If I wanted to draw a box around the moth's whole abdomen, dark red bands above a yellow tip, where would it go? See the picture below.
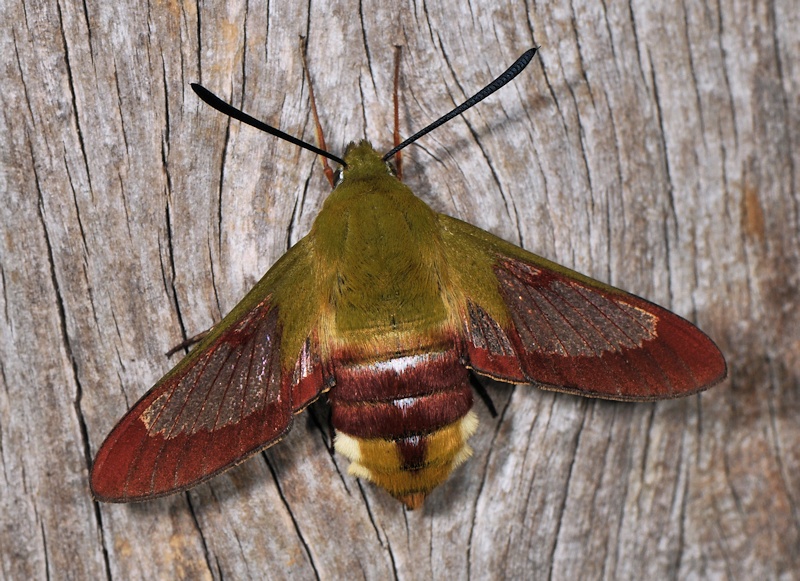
[328,344,478,508]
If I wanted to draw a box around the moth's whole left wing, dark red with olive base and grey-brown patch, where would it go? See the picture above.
[91,241,331,502]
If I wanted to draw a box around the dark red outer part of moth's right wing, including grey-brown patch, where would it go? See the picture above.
[473,257,727,401]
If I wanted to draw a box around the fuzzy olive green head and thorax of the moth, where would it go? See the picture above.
[309,141,448,342]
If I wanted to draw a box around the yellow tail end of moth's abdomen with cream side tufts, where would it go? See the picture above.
[334,411,478,509]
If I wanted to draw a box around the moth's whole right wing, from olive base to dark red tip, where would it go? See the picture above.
[440,216,727,401]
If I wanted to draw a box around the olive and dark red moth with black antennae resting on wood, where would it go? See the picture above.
[91,48,726,509]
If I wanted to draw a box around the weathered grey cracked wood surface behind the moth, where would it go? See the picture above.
[0,0,800,579]
